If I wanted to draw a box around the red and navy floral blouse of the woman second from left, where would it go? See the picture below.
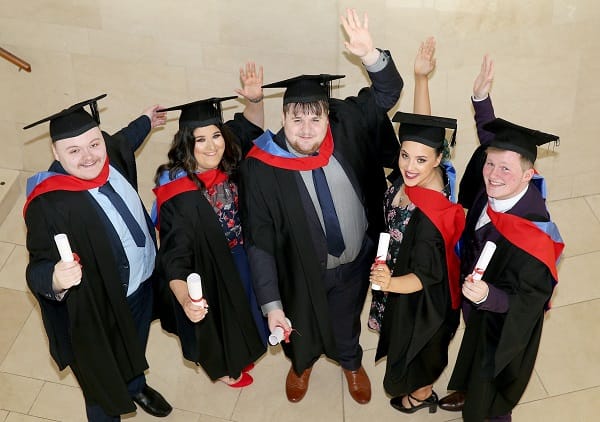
[203,180,244,249]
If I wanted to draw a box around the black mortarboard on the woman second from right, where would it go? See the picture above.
[392,111,456,149]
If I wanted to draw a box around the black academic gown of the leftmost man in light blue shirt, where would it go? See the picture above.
[25,117,154,416]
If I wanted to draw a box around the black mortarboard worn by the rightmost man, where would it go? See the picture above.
[483,119,560,163]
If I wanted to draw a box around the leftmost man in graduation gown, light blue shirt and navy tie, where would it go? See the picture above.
[23,95,172,421]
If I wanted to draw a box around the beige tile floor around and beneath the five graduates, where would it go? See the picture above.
[0,0,600,422]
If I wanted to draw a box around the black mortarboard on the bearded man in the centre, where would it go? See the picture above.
[263,73,346,105]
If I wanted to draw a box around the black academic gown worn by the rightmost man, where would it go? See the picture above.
[448,183,554,421]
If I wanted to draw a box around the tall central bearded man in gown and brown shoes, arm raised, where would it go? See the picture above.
[241,11,403,404]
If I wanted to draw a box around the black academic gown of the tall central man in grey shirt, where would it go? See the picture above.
[241,55,402,374]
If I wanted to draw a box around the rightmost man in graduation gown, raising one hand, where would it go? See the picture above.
[448,56,564,422]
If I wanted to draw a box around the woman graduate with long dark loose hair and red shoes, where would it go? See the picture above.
[154,63,267,387]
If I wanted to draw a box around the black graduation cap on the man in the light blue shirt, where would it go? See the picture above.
[23,94,106,142]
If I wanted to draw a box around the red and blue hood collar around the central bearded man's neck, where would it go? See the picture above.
[246,125,334,170]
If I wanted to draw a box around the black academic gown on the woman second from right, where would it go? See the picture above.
[375,181,459,396]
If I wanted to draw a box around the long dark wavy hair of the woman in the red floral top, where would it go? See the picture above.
[154,124,242,189]
